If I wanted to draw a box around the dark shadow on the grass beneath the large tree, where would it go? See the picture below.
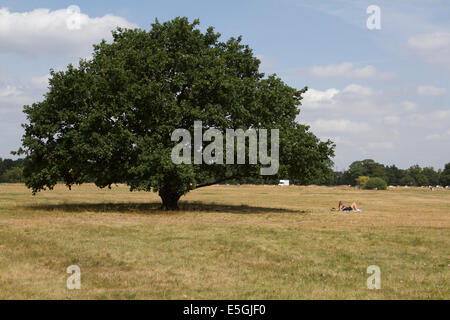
[26,201,308,214]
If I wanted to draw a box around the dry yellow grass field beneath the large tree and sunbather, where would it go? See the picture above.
[0,184,450,299]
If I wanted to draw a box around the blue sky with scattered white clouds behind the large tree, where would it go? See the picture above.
[0,0,450,170]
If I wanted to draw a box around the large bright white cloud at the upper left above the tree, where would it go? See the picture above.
[0,8,136,56]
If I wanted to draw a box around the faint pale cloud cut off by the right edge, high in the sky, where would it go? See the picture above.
[408,32,450,68]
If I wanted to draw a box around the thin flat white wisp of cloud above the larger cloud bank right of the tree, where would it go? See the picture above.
[309,62,394,79]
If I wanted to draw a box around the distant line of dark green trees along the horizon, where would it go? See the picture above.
[0,158,450,186]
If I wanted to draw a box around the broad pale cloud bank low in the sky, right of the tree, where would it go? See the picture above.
[299,83,450,170]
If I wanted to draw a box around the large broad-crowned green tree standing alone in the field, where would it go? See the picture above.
[19,18,334,207]
